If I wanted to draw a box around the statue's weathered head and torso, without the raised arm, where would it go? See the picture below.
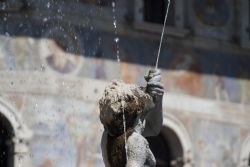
[99,81,155,167]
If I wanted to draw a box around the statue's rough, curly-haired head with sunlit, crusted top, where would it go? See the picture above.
[99,81,153,136]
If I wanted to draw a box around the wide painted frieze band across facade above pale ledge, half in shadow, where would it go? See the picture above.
[0,30,250,104]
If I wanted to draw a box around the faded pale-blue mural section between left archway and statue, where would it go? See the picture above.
[23,97,103,167]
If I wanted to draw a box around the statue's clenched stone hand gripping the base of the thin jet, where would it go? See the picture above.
[145,69,164,102]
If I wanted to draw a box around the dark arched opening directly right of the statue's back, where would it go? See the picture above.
[147,127,184,167]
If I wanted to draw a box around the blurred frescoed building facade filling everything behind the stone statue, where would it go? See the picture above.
[0,0,250,167]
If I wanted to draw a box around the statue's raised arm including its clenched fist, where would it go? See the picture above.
[143,70,164,136]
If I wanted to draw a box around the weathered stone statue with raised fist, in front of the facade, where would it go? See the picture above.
[99,70,164,167]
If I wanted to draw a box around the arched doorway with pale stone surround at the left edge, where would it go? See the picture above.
[0,98,32,167]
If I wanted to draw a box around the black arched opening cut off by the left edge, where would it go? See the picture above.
[0,114,14,167]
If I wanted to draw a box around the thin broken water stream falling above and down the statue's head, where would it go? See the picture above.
[112,1,128,162]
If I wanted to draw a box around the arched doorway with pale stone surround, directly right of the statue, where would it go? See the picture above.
[147,114,193,167]
